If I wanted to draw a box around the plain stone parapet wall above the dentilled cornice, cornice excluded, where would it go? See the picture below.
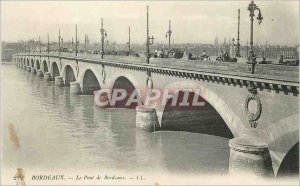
[13,52,299,82]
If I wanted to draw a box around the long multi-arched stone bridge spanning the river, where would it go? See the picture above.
[13,53,299,176]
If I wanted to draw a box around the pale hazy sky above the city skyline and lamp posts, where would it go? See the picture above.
[1,0,299,45]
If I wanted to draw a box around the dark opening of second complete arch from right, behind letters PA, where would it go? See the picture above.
[111,76,142,109]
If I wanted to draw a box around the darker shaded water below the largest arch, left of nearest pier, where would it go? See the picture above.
[157,132,229,173]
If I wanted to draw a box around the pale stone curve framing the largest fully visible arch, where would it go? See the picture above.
[155,81,245,137]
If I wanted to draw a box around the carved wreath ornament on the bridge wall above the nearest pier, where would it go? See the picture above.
[244,84,262,128]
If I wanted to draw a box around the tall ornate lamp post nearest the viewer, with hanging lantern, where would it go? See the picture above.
[248,1,263,74]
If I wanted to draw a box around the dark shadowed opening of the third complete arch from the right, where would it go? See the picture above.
[82,69,101,95]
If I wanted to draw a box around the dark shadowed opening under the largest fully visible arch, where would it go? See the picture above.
[160,91,234,139]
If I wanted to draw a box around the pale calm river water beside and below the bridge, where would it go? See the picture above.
[1,65,237,184]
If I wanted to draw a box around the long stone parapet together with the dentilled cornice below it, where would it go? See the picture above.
[15,52,299,94]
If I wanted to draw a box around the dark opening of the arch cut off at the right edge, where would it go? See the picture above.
[277,142,299,178]
